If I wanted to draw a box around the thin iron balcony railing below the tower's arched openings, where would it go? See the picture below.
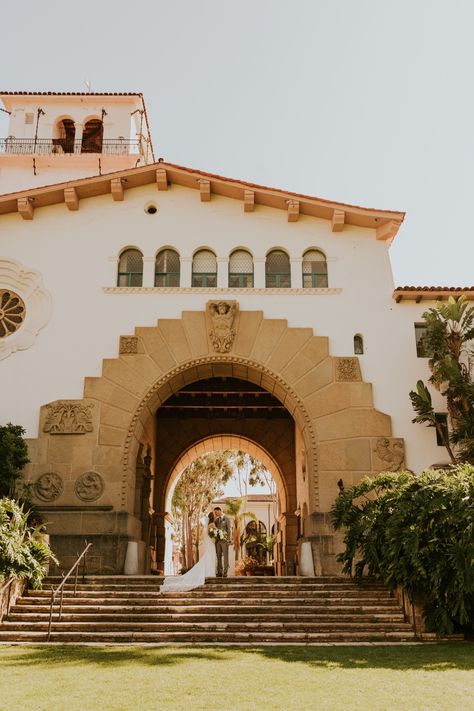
[0,136,144,156]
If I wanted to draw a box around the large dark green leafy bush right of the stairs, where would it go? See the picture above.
[331,464,474,634]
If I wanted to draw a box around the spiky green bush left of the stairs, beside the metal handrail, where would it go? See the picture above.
[0,498,57,588]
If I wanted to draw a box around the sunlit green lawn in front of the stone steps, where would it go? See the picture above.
[0,643,474,711]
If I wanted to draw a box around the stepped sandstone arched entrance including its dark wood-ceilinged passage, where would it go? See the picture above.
[28,301,403,573]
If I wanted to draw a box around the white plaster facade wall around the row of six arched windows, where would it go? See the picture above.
[0,186,445,470]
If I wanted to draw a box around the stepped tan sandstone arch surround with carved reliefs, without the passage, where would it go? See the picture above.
[28,302,404,573]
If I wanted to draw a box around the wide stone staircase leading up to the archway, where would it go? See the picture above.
[0,576,415,645]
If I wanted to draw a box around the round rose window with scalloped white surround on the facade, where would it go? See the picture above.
[0,259,51,360]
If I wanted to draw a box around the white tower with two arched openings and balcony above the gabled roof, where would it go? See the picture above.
[0,91,154,194]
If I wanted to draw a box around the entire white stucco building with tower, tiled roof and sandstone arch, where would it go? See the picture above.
[0,92,468,572]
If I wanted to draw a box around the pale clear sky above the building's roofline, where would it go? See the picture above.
[0,0,474,286]
